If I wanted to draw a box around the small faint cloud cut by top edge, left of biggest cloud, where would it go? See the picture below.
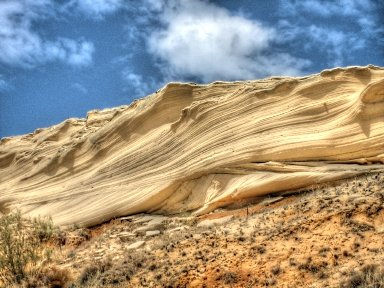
[68,0,123,19]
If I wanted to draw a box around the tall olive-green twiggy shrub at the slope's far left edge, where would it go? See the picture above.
[0,212,53,287]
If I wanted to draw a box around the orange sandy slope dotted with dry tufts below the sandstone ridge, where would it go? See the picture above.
[50,173,384,288]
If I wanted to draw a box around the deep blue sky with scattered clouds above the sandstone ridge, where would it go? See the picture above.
[0,0,384,137]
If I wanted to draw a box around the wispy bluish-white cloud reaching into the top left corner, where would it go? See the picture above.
[0,0,94,67]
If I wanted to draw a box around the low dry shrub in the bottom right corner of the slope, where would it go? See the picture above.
[340,265,384,288]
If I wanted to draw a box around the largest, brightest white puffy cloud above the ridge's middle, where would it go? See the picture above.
[144,0,309,82]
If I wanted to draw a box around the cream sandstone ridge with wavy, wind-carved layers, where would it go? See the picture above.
[0,65,384,226]
